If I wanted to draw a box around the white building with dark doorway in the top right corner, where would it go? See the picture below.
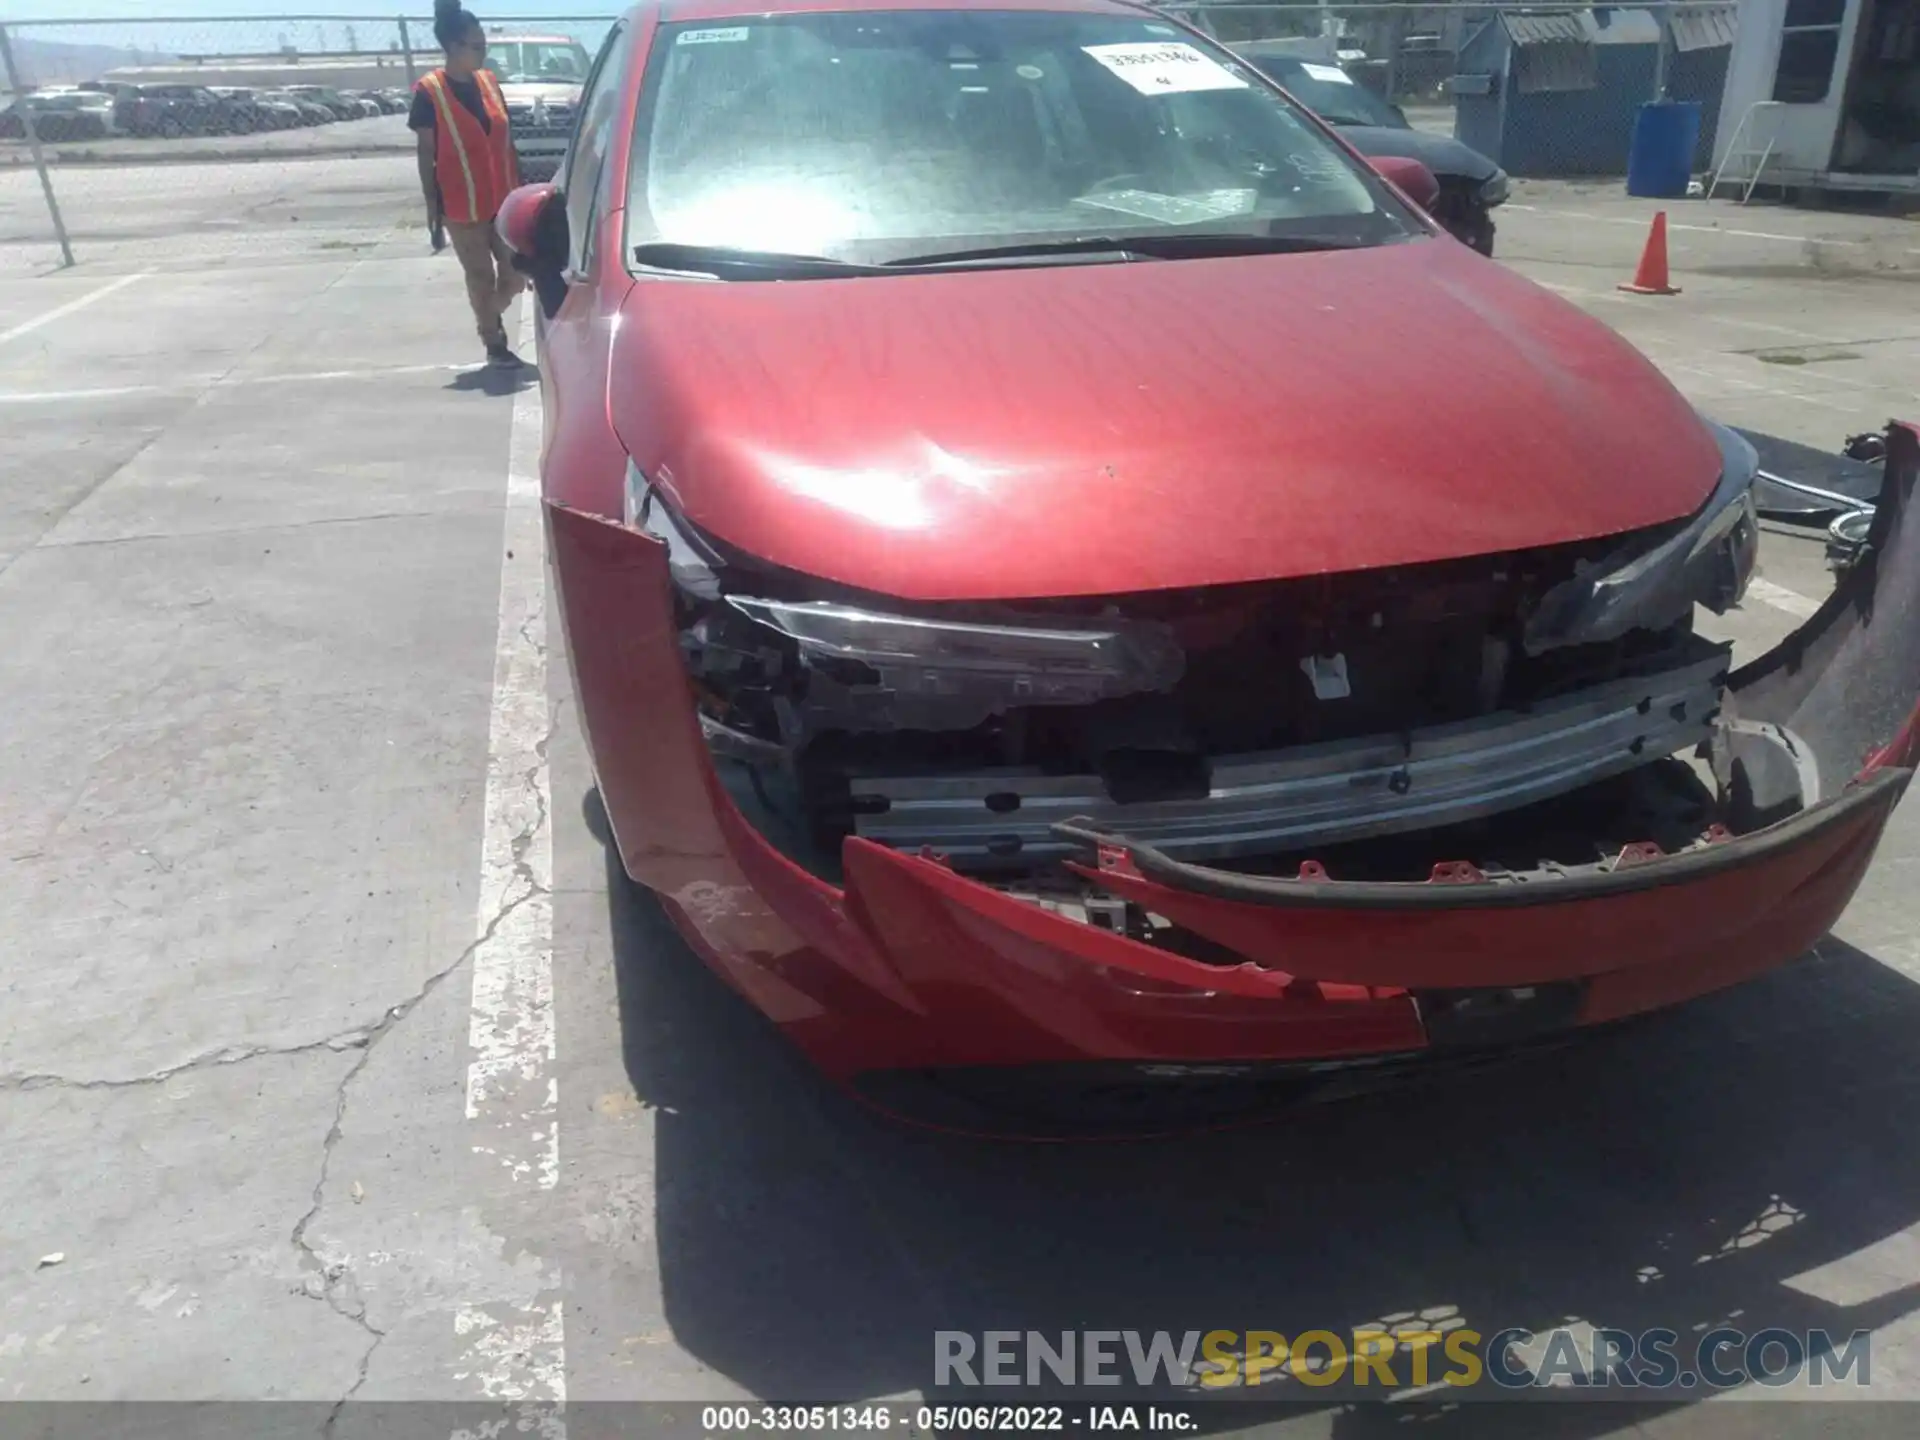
[1720,0,1920,192]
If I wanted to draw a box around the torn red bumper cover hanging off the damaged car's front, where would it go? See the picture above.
[547,426,1920,1079]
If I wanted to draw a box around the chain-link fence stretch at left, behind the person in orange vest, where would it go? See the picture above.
[0,10,616,273]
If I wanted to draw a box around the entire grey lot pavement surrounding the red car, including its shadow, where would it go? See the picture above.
[0,161,1920,1438]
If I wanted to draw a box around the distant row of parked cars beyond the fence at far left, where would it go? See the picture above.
[0,81,409,142]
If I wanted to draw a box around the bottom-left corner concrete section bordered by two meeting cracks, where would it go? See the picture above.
[0,1050,372,1400]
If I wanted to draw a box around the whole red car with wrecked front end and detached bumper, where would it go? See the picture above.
[501,0,1920,1123]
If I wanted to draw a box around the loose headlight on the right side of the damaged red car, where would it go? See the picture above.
[1523,420,1761,655]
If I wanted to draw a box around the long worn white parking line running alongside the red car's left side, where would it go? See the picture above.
[455,303,566,1432]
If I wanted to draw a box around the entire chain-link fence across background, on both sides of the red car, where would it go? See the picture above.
[0,0,1740,267]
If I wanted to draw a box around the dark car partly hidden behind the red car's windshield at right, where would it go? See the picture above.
[1235,40,1507,255]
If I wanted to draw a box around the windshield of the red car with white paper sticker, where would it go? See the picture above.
[628,10,1419,265]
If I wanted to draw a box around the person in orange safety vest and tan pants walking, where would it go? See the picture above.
[407,0,524,365]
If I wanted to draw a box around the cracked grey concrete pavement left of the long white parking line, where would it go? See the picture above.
[0,219,529,1405]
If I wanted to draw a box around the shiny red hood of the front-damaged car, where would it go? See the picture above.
[609,238,1720,601]
